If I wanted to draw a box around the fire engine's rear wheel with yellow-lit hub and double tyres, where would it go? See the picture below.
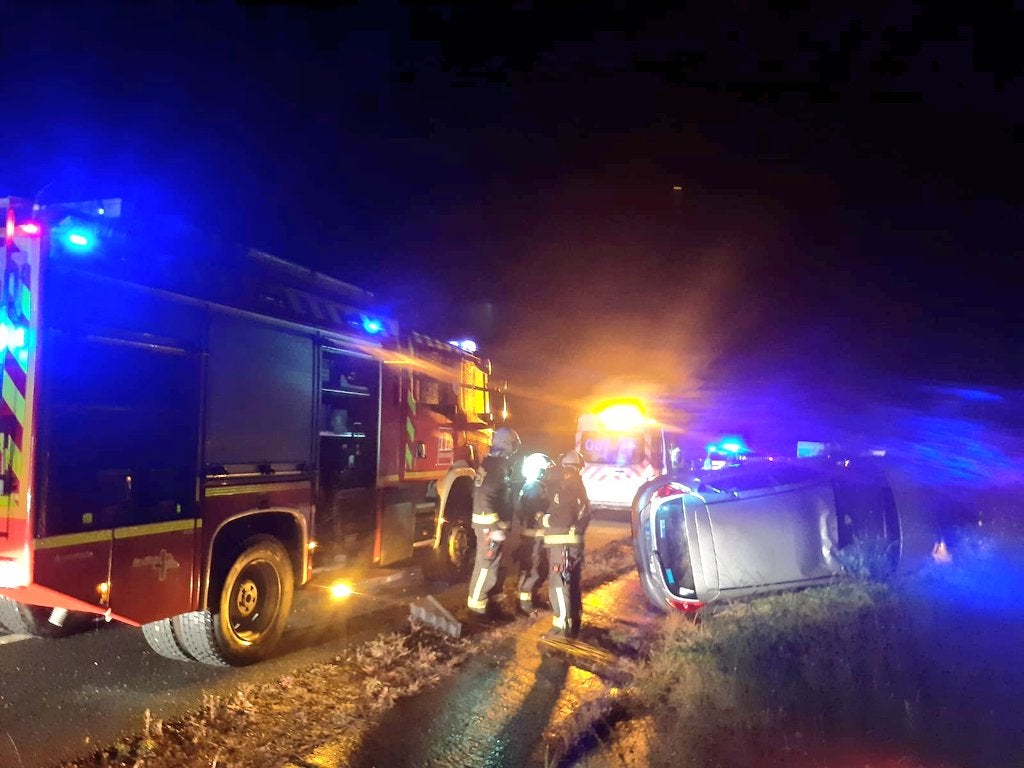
[171,537,295,667]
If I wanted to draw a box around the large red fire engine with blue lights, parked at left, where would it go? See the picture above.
[0,198,504,665]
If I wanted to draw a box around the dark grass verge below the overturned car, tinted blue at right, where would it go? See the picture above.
[574,537,1024,768]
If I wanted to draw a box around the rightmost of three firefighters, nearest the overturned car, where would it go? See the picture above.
[542,451,590,638]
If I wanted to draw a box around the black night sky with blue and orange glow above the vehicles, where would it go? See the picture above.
[0,2,1024,450]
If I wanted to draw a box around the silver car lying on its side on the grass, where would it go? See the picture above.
[632,458,901,611]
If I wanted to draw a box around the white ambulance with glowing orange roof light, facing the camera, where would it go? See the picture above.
[575,399,671,510]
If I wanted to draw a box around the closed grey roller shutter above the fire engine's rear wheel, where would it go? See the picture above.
[206,315,314,466]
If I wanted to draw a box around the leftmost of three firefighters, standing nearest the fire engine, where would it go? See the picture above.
[466,427,521,615]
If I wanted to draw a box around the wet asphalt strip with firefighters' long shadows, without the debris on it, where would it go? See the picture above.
[344,572,660,768]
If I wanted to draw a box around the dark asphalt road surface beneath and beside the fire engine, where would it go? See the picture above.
[0,520,629,768]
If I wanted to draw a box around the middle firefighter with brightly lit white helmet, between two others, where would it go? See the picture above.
[516,454,555,615]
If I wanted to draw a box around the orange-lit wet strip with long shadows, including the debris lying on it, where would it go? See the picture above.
[339,572,660,768]
